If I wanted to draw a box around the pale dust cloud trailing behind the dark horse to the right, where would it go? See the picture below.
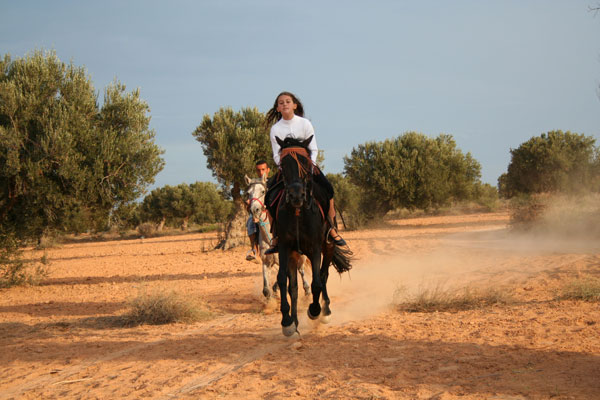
[328,220,600,324]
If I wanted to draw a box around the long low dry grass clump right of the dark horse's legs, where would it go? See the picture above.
[394,285,512,312]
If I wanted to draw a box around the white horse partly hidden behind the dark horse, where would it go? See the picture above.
[244,175,310,299]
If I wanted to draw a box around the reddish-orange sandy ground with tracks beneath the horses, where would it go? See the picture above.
[0,213,600,399]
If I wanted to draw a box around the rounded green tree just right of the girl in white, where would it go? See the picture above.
[344,132,481,217]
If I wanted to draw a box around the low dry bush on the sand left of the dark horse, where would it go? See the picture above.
[123,292,212,325]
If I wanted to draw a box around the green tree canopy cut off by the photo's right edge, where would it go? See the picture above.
[498,130,600,197]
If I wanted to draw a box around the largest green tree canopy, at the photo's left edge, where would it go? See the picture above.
[0,51,164,239]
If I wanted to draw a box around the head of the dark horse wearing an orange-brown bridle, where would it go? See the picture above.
[276,136,313,208]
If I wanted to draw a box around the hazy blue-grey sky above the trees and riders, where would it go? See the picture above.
[0,0,600,187]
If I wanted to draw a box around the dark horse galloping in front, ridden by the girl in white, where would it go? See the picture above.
[271,136,351,336]
